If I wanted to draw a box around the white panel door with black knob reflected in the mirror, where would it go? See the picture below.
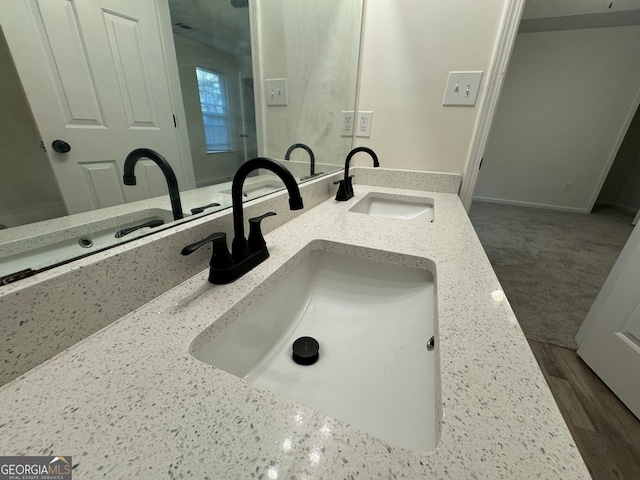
[0,0,195,213]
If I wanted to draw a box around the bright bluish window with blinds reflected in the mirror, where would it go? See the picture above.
[196,67,231,153]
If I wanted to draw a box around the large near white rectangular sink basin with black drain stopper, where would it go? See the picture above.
[191,244,439,451]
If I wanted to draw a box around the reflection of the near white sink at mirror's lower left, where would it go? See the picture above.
[0,208,173,277]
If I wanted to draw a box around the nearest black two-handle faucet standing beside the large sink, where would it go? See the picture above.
[181,157,303,285]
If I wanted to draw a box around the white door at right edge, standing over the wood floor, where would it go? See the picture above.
[576,222,640,418]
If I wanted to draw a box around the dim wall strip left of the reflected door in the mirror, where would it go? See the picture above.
[0,32,67,227]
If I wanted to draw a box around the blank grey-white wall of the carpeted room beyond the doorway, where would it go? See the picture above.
[475,26,640,211]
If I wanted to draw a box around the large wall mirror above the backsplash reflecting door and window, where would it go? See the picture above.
[0,0,363,284]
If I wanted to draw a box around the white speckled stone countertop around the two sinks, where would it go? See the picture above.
[0,185,590,479]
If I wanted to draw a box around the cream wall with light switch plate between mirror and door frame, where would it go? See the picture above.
[357,0,508,173]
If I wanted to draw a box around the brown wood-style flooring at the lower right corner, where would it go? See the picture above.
[529,340,640,480]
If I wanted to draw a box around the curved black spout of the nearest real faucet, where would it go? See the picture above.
[231,157,304,262]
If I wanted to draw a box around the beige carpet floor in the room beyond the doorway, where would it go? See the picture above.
[469,202,633,350]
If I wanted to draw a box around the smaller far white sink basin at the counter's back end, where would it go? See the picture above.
[349,192,433,222]
